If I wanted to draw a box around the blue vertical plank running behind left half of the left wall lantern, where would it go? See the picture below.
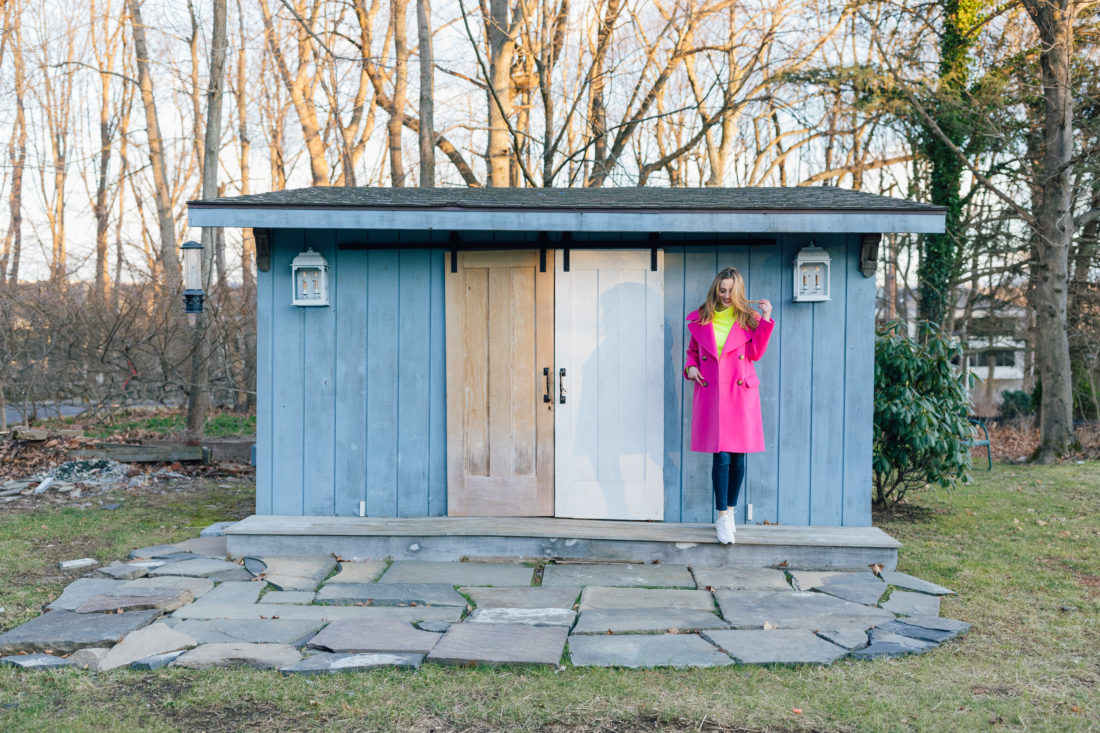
[271,229,306,516]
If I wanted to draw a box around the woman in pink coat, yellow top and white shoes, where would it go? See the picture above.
[684,267,776,545]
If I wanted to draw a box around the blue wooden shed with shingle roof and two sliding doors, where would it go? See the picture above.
[189,188,945,563]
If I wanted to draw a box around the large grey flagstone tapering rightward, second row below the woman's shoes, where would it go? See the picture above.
[714,591,893,631]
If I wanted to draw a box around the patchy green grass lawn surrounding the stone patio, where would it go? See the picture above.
[0,462,1100,731]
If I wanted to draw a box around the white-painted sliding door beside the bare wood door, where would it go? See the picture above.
[554,250,664,519]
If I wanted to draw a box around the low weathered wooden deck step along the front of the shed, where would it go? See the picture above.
[226,515,901,570]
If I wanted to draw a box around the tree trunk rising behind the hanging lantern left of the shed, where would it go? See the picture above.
[187,0,226,438]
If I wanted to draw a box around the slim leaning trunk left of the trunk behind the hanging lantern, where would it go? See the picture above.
[127,0,179,293]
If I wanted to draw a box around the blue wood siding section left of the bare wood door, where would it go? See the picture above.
[256,229,447,516]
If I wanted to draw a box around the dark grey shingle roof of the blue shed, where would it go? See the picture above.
[189,186,945,214]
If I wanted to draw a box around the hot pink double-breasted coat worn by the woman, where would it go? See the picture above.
[684,310,776,453]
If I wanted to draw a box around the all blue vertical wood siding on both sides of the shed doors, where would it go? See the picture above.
[256,230,875,519]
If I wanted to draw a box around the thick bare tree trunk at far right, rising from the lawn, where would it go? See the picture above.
[1024,0,1077,463]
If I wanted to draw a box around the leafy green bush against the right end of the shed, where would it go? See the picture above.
[872,320,971,510]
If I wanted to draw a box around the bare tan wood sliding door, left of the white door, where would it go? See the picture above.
[444,250,554,516]
